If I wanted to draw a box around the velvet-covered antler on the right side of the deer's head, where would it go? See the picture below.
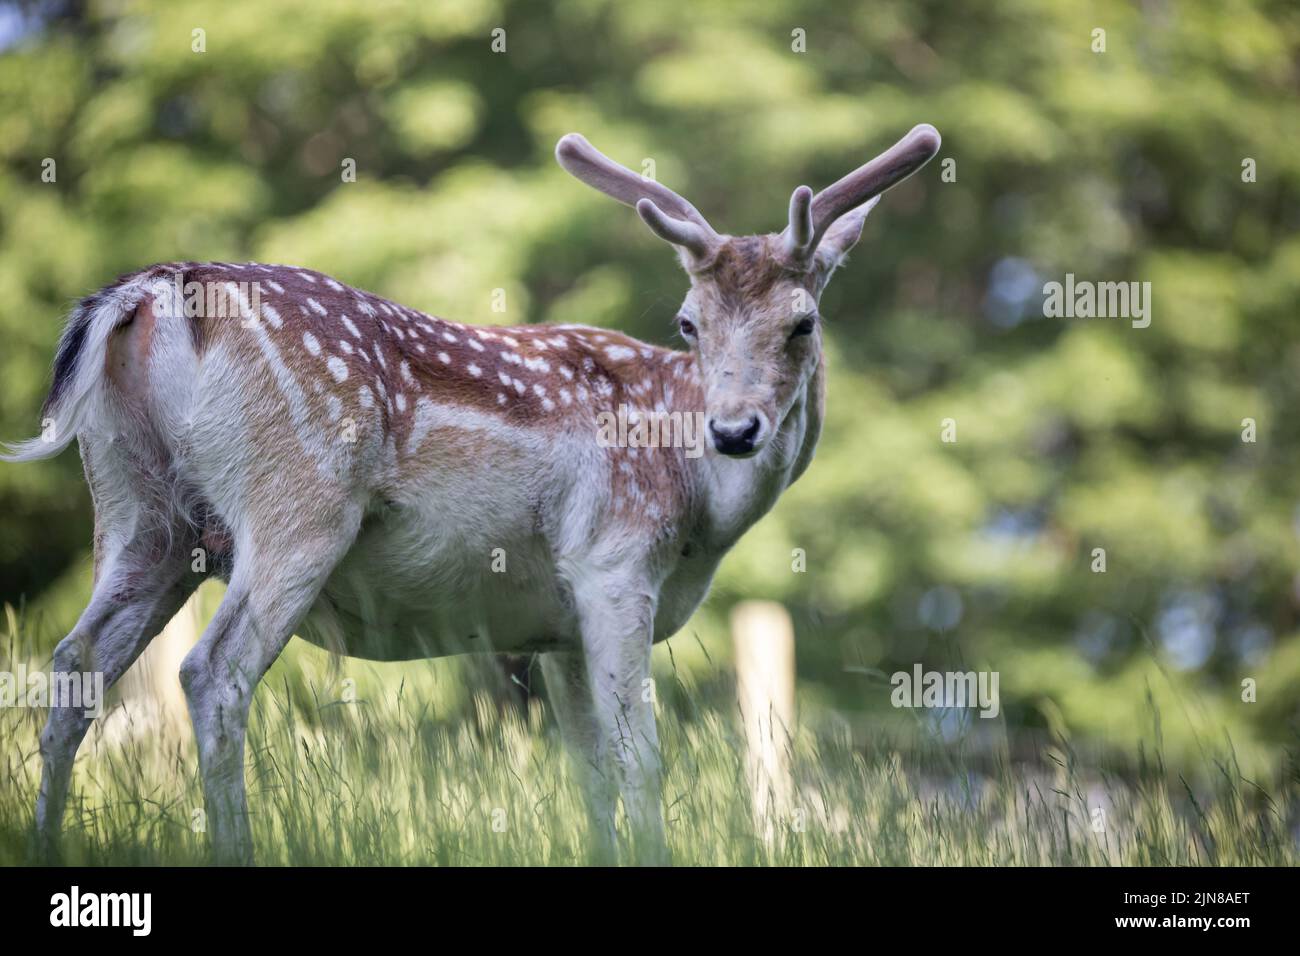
[781,124,941,261]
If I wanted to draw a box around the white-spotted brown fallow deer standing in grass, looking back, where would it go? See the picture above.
[4,124,940,865]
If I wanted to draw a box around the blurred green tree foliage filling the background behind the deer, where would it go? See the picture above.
[0,0,1300,779]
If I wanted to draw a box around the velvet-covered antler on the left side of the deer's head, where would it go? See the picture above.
[555,133,722,265]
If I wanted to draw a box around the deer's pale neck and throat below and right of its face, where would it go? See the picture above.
[694,360,826,553]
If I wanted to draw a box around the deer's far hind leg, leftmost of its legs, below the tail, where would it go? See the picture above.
[36,542,198,858]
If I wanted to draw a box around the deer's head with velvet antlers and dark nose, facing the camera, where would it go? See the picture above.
[555,124,940,458]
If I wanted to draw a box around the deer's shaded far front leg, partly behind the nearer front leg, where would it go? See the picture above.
[542,652,618,864]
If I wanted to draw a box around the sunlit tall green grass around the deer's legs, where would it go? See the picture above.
[0,613,1300,865]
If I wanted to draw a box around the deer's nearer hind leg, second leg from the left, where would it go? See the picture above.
[181,502,361,864]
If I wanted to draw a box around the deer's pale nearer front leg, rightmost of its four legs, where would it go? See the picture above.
[575,581,668,864]
